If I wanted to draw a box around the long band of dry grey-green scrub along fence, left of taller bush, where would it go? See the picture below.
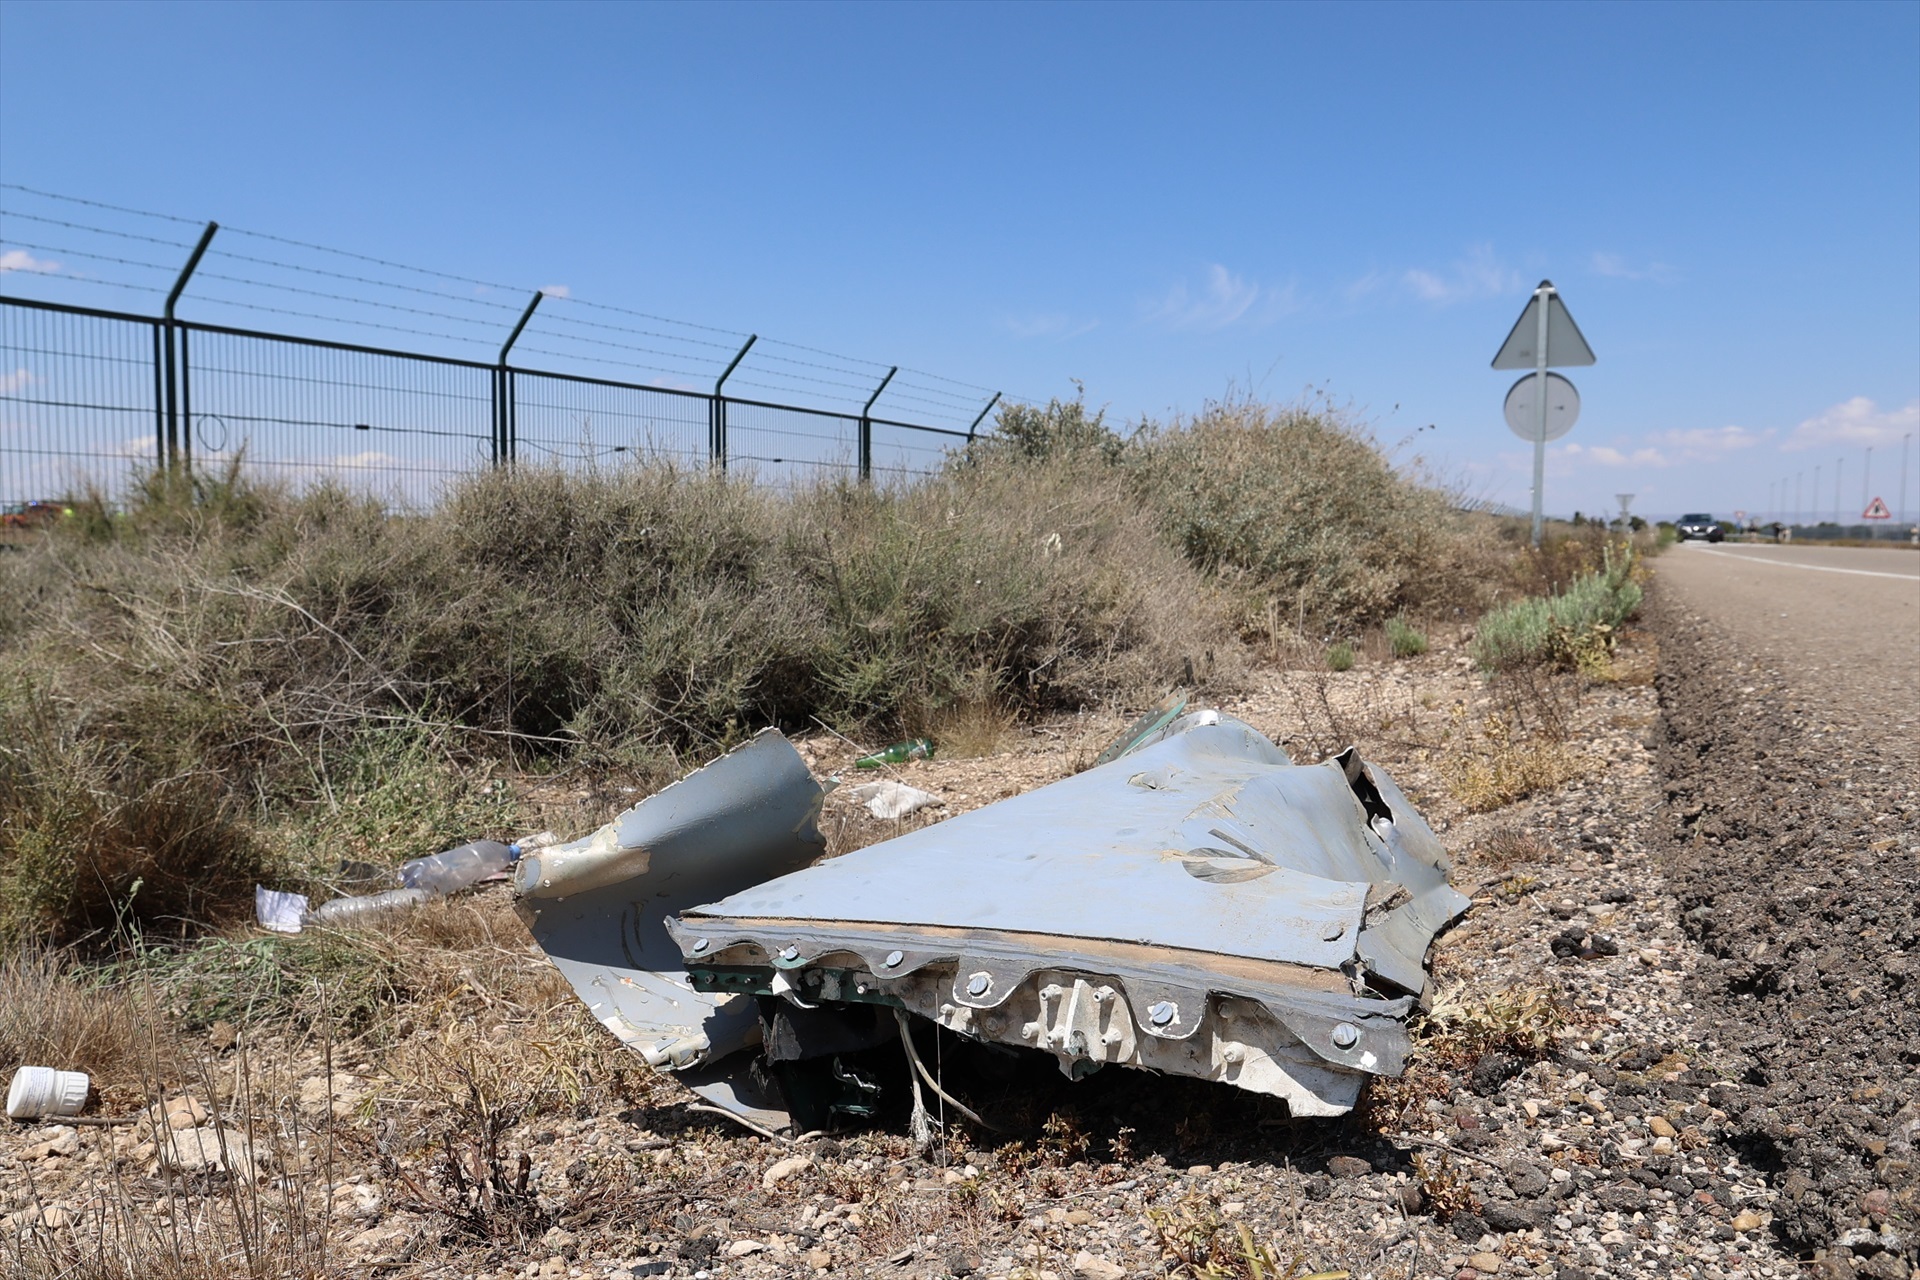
[0,453,1231,940]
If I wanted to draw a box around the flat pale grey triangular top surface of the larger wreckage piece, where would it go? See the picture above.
[689,720,1420,969]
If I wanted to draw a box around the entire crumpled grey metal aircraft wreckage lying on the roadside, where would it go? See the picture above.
[515,710,1467,1126]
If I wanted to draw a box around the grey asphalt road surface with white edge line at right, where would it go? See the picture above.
[1653,543,1920,762]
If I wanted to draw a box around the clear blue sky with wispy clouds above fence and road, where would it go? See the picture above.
[0,0,1920,514]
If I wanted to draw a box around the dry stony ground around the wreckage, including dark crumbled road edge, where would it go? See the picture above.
[0,557,1920,1280]
